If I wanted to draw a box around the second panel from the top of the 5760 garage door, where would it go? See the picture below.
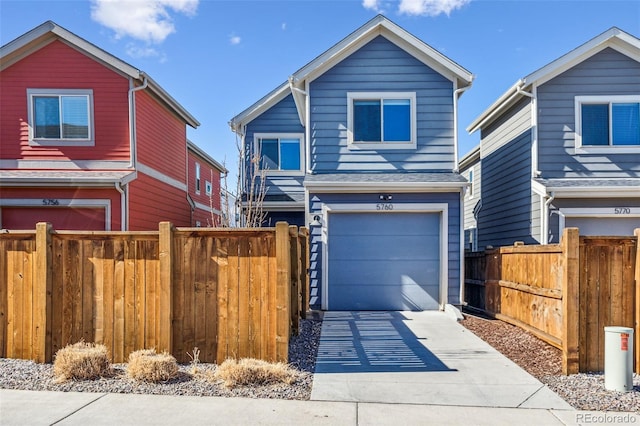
[329,235,440,260]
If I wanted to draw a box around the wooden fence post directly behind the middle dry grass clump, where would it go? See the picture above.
[157,222,173,352]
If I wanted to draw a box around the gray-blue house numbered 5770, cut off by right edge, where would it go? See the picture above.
[461,28,640,248]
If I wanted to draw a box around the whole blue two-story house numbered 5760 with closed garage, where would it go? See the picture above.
[230,15,472,310]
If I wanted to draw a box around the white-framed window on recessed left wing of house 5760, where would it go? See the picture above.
[253,133,304,175]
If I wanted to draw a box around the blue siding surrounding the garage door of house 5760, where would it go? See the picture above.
[309,192,461,308]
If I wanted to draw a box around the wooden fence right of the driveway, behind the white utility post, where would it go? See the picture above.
[465,228,640,374]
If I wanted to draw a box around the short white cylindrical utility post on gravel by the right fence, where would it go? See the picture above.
[604,327,633,392]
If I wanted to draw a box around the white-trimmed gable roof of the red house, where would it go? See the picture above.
[0,21,200,128]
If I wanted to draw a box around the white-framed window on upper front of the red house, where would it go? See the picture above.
[27,89,95,146]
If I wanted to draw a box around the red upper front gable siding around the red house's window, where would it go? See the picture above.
[0,41,131,161]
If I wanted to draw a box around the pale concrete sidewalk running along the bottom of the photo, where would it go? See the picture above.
[0,389,640,426]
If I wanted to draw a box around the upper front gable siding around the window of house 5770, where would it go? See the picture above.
[538,48,640,178]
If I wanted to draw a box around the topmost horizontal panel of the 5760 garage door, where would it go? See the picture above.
[329,213,439,237]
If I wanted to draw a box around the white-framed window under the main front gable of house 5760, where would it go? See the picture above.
[347,92,417,149]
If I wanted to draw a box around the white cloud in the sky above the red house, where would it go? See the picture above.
[91,0,199,43]
